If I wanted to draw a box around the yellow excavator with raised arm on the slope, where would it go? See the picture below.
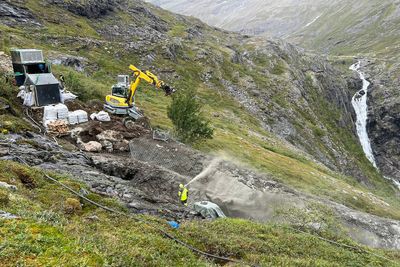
[104,65,175,123]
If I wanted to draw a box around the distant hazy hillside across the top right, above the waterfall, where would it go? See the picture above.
[145,0,399,55]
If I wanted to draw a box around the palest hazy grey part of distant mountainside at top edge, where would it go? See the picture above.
[148,0,332,38]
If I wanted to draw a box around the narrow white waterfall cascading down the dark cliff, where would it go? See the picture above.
[350,62,378,169]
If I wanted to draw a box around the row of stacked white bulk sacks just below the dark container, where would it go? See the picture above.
[43,104,88,127]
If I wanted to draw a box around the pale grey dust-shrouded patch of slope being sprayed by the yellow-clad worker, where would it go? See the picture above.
[187,158,302,221]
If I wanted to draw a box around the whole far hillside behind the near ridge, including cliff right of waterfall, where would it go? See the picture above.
[148,0,400,186]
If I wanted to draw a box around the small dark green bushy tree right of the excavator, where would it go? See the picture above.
[168,89,213,143]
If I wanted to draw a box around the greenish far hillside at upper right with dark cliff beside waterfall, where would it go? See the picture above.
[291,1,400,184]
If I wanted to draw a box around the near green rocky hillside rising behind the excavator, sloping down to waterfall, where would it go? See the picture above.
[1,0,398,220]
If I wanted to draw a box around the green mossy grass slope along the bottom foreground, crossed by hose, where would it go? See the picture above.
[0,161,400,266]
